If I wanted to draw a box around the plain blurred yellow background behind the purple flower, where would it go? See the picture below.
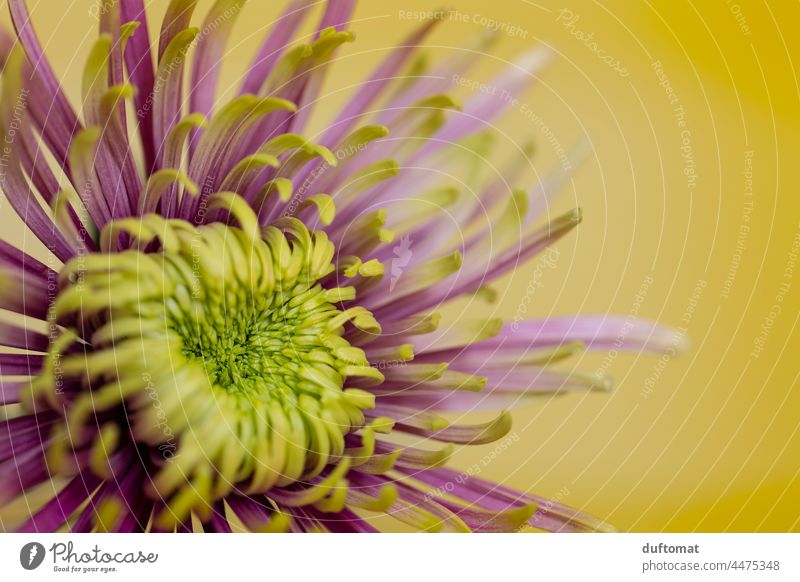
[0,0,800,531]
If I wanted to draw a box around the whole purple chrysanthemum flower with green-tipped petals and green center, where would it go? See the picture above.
[0,0,671,532]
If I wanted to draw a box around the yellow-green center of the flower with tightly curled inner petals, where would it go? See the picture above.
[29,194,383,526]
